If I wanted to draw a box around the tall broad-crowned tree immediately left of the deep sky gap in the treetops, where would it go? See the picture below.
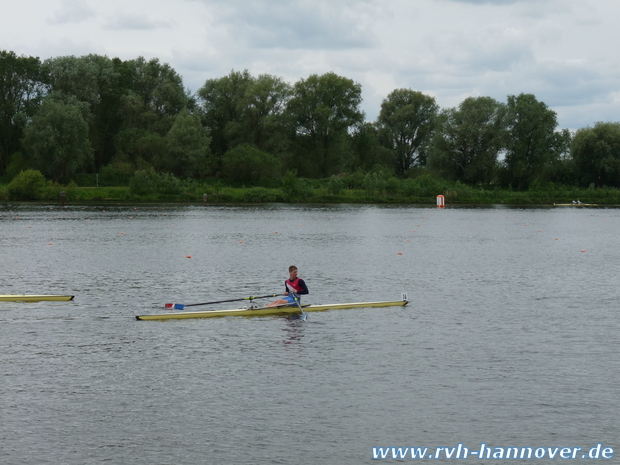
[288,73,364,177]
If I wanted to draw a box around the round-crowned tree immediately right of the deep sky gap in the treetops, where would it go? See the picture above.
[377,89,439,175]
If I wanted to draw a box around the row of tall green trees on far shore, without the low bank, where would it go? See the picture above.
[0,51,620,190]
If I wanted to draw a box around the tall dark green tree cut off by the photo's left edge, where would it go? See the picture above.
[0,50,45,175]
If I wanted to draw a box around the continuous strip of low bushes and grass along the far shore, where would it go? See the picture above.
[0,170,620,206]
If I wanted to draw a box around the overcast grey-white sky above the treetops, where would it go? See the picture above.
[0,0,620,130]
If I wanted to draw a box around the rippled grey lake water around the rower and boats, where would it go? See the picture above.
[0,204,620,465]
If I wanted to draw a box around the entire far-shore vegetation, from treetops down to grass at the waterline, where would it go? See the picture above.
[0,50,620,205]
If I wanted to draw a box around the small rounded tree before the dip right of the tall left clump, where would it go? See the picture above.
[164,110,211,177]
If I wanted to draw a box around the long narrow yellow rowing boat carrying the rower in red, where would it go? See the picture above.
[136,300,409,320]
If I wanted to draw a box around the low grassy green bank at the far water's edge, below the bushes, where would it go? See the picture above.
[0,178,620,205]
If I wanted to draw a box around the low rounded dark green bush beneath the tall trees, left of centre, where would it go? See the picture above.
[222,144,280,183]
